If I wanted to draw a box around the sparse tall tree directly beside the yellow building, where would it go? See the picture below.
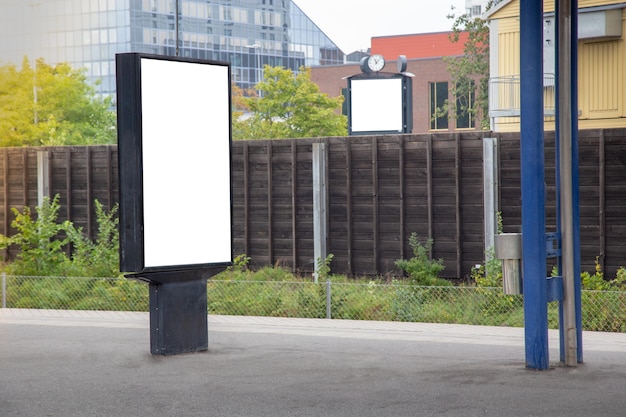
[442,1,494,129]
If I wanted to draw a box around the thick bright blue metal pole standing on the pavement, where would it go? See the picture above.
[520,0,550,370]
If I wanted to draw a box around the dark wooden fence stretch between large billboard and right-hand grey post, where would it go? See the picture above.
[233,134,483,277]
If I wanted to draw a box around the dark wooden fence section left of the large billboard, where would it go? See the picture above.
[0,146,118,244]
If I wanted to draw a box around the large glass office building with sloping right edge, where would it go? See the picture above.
[0,0,344,95]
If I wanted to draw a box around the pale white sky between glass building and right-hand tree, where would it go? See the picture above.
[294,0,465,54]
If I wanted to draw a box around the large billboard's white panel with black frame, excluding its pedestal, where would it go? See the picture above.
[116,53,232,273]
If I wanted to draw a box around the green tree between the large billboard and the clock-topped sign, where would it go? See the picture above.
[233,66,347,139]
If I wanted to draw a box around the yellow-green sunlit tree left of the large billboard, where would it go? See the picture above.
[0,58,116,146]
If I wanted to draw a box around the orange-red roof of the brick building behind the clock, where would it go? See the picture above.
[372,32,469,61]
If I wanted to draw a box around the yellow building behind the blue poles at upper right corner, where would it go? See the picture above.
[487,0,626,132]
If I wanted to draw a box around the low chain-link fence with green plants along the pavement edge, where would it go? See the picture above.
[1,274,626,332]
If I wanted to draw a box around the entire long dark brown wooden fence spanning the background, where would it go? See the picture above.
[0,129,626,279]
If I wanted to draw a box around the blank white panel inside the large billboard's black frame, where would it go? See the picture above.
[140,57,232,268]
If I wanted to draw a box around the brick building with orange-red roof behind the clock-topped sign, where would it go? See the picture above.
[311,32,480,133]
